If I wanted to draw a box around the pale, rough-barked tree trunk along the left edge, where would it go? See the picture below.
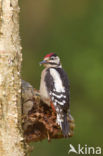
[0,0,25,156]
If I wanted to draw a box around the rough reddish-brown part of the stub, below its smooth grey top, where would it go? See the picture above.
[24,99,73,142]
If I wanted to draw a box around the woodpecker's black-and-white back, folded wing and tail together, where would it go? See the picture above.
[45,68,70,136]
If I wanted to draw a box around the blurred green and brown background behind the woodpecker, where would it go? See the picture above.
[20,0,103,156]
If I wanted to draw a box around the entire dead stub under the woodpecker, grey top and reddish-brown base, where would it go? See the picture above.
[22,81,74,142]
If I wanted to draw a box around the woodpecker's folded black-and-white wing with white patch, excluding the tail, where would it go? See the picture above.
[45,68,70,109]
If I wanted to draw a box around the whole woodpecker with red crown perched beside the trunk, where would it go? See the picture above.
[40,53,70,137]
